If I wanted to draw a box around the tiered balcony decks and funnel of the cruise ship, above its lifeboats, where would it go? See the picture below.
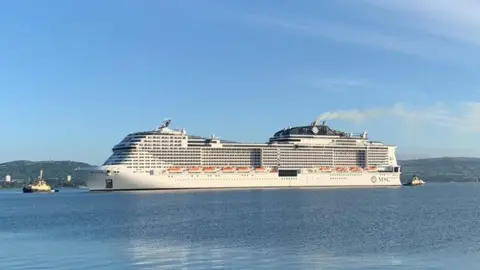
[105,118,395,169]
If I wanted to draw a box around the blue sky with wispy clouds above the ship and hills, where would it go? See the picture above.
[0,0,480,164]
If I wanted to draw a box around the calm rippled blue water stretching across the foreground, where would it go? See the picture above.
[0,183,480,270]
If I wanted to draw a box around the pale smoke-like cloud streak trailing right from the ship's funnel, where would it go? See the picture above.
[317,102,480,133]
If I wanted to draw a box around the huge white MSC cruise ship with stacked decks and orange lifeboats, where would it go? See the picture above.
[82,119,401,191]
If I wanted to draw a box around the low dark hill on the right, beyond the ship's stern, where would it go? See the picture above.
[398,157,480,182]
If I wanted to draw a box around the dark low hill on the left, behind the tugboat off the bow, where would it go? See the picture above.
[0,160,92,185]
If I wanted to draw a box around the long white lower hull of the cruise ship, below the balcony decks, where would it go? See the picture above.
[87,168,402,191]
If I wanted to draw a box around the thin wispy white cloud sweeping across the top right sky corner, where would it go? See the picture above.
[183,0,480,64]
